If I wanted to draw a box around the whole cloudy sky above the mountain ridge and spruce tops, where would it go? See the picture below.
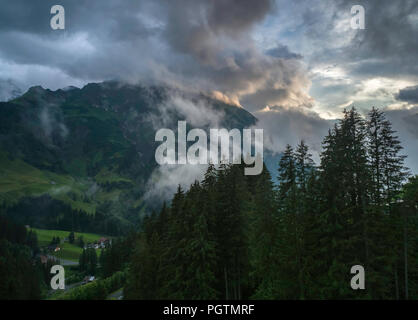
[0,0,418,173]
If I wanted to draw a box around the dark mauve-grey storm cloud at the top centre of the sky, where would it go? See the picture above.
[164,0,273,61]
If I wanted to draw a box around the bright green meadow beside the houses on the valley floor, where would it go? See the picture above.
[32,228,106,261]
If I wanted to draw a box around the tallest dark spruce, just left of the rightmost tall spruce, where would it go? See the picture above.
[320,108,369,297]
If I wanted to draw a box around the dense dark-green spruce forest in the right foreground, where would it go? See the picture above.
[124,108,418,299]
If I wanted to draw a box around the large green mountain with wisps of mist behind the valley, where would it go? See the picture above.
[0,81,256,234]
